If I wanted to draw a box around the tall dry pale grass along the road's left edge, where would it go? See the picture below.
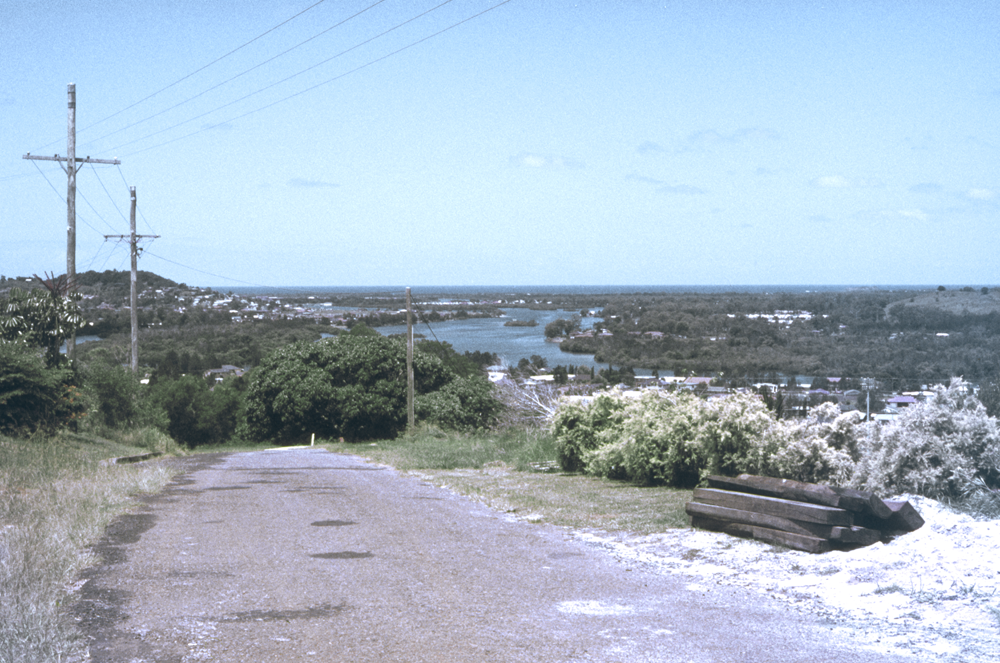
[0,432,172,663]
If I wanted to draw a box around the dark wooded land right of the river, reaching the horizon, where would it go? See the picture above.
[560,288,1000,384]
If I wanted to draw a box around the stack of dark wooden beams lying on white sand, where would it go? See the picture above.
[685,474,924,553]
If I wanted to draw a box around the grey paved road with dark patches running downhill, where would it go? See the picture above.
[76,448,912,663]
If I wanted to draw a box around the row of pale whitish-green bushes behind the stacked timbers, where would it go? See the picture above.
[552,379,1000,500]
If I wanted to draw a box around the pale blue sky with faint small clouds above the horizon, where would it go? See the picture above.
[0,0,1000,286]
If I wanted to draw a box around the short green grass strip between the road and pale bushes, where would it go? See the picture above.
[323,430,691,534]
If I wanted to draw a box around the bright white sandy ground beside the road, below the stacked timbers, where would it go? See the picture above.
[564,495,1000,663]
